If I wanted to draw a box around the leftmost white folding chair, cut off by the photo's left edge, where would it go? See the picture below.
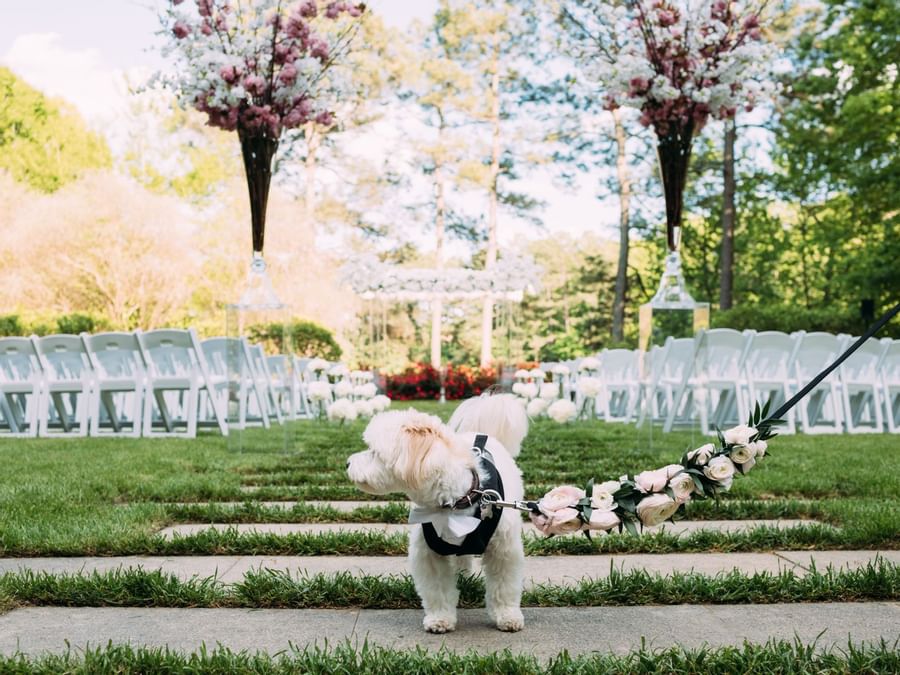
[0,337,43,437]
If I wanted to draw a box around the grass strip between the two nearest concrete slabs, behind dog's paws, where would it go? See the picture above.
[0,560,900,609]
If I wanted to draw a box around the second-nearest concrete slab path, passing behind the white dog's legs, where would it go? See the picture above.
[0,551,888,586]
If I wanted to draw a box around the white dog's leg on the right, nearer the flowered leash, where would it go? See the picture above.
[482,512,525,632]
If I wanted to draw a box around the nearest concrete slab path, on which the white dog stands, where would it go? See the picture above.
[0,602,900,659]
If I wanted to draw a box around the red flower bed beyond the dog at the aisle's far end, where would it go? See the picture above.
[385,363,497,401]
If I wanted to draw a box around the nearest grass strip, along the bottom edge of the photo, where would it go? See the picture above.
[0,638,900,675]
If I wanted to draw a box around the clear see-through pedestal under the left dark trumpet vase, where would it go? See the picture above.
[225,253,297,452]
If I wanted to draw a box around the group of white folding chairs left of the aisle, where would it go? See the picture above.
[0,329,358,437]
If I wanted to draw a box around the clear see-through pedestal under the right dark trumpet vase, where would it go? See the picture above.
[638,250,709,447]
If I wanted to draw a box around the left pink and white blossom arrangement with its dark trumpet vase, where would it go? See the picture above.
[161,0,364,252]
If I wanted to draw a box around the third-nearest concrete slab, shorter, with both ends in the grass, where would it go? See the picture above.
[159,519,820,538]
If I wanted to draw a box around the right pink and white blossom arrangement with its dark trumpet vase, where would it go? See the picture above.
[564,0,771,251]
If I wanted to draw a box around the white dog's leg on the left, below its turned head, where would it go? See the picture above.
[409,527,459,633]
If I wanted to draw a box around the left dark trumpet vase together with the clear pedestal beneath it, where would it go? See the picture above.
[225,132,298,451]
